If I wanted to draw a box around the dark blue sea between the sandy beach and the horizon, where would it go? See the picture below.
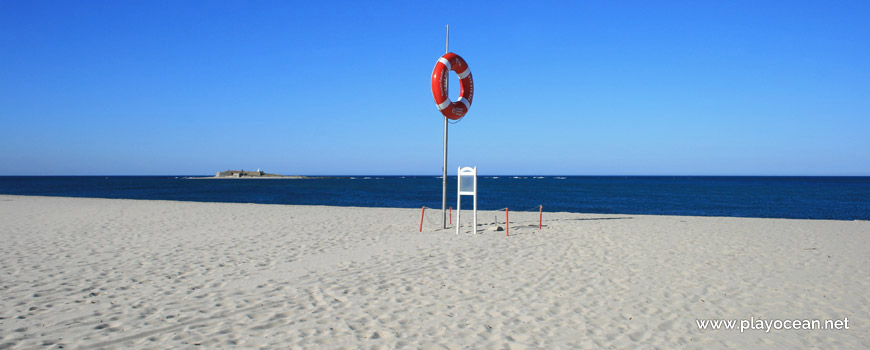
[0,176,870,220]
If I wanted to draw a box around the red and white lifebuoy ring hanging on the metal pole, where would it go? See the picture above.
[432,52,474,120]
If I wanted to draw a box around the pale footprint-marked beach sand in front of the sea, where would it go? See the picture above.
[0,196,870,349]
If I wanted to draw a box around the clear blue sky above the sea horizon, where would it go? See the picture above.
[0,0,870,175]
